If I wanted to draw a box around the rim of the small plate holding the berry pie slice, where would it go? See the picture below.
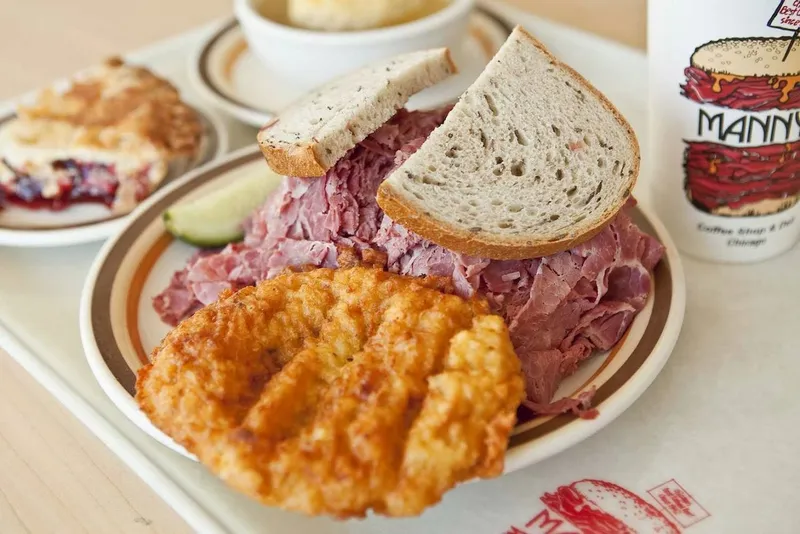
[0,105,230,248]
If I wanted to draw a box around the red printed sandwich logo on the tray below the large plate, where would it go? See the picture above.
[503,479,711,534]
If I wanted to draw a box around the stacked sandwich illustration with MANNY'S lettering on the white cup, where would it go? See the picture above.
[681,36,800,217]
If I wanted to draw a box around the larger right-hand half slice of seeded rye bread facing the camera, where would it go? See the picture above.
[378,27,640,259]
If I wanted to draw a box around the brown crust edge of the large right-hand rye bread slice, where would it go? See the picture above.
[377,26,641,260]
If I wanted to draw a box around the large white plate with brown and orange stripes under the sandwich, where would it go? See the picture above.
[80,147,685,471]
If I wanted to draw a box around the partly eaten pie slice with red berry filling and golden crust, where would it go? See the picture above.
[0,58,205,214]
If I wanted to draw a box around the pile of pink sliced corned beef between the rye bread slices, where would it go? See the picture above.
[154,108,663,415]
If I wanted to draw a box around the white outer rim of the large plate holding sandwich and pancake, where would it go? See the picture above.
[79,146,686,473]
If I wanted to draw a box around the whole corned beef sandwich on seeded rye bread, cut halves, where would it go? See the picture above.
[154,29,663,416]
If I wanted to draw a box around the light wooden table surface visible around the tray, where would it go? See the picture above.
[0,0,645,534]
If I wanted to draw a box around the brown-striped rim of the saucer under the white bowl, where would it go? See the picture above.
[188,6,513,128]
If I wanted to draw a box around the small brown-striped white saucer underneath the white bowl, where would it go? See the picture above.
[190,10,511,128]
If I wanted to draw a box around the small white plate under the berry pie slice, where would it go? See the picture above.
[0,108,228,251]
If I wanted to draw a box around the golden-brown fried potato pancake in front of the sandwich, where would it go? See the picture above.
[136,267,524,518]
